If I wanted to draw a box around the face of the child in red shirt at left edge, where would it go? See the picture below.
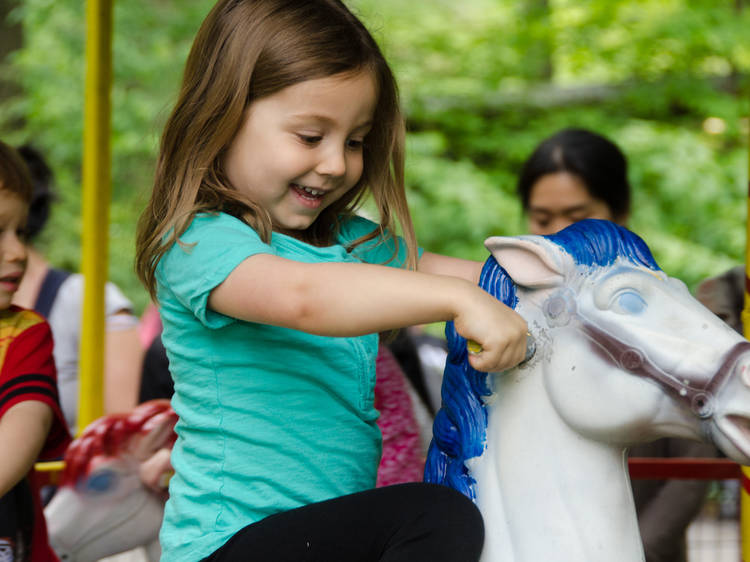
[0,189,29,310]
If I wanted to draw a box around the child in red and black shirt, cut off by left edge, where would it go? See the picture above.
[0,141,70,562]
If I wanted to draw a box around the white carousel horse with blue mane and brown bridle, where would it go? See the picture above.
[425,220,750,562]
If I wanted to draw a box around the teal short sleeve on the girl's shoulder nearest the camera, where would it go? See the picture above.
[156,213,276,328]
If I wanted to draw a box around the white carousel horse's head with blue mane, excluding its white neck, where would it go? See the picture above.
[426,220,750,496]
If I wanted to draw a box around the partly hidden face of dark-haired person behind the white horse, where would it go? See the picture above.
[528,172,615,234]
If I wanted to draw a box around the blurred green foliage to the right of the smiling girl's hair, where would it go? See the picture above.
[355,0,750,286]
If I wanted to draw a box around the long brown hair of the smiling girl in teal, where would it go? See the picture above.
[136,0,417,297]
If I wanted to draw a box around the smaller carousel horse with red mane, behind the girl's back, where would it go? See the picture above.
[44,400,177,562]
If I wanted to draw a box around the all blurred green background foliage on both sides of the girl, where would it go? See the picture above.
[0,0,750,306]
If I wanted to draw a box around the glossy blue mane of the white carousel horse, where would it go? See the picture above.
[424,219,660,499]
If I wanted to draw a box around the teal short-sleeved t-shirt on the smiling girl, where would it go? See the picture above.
[156,213,414,562]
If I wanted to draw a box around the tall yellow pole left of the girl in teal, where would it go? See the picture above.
[78,0,112,434]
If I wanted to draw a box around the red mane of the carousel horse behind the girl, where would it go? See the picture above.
[60,400,177,486]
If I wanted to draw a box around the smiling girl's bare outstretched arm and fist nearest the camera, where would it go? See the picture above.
[208,254,526,371]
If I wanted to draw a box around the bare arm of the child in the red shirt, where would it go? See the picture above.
[0,400,52,497]
